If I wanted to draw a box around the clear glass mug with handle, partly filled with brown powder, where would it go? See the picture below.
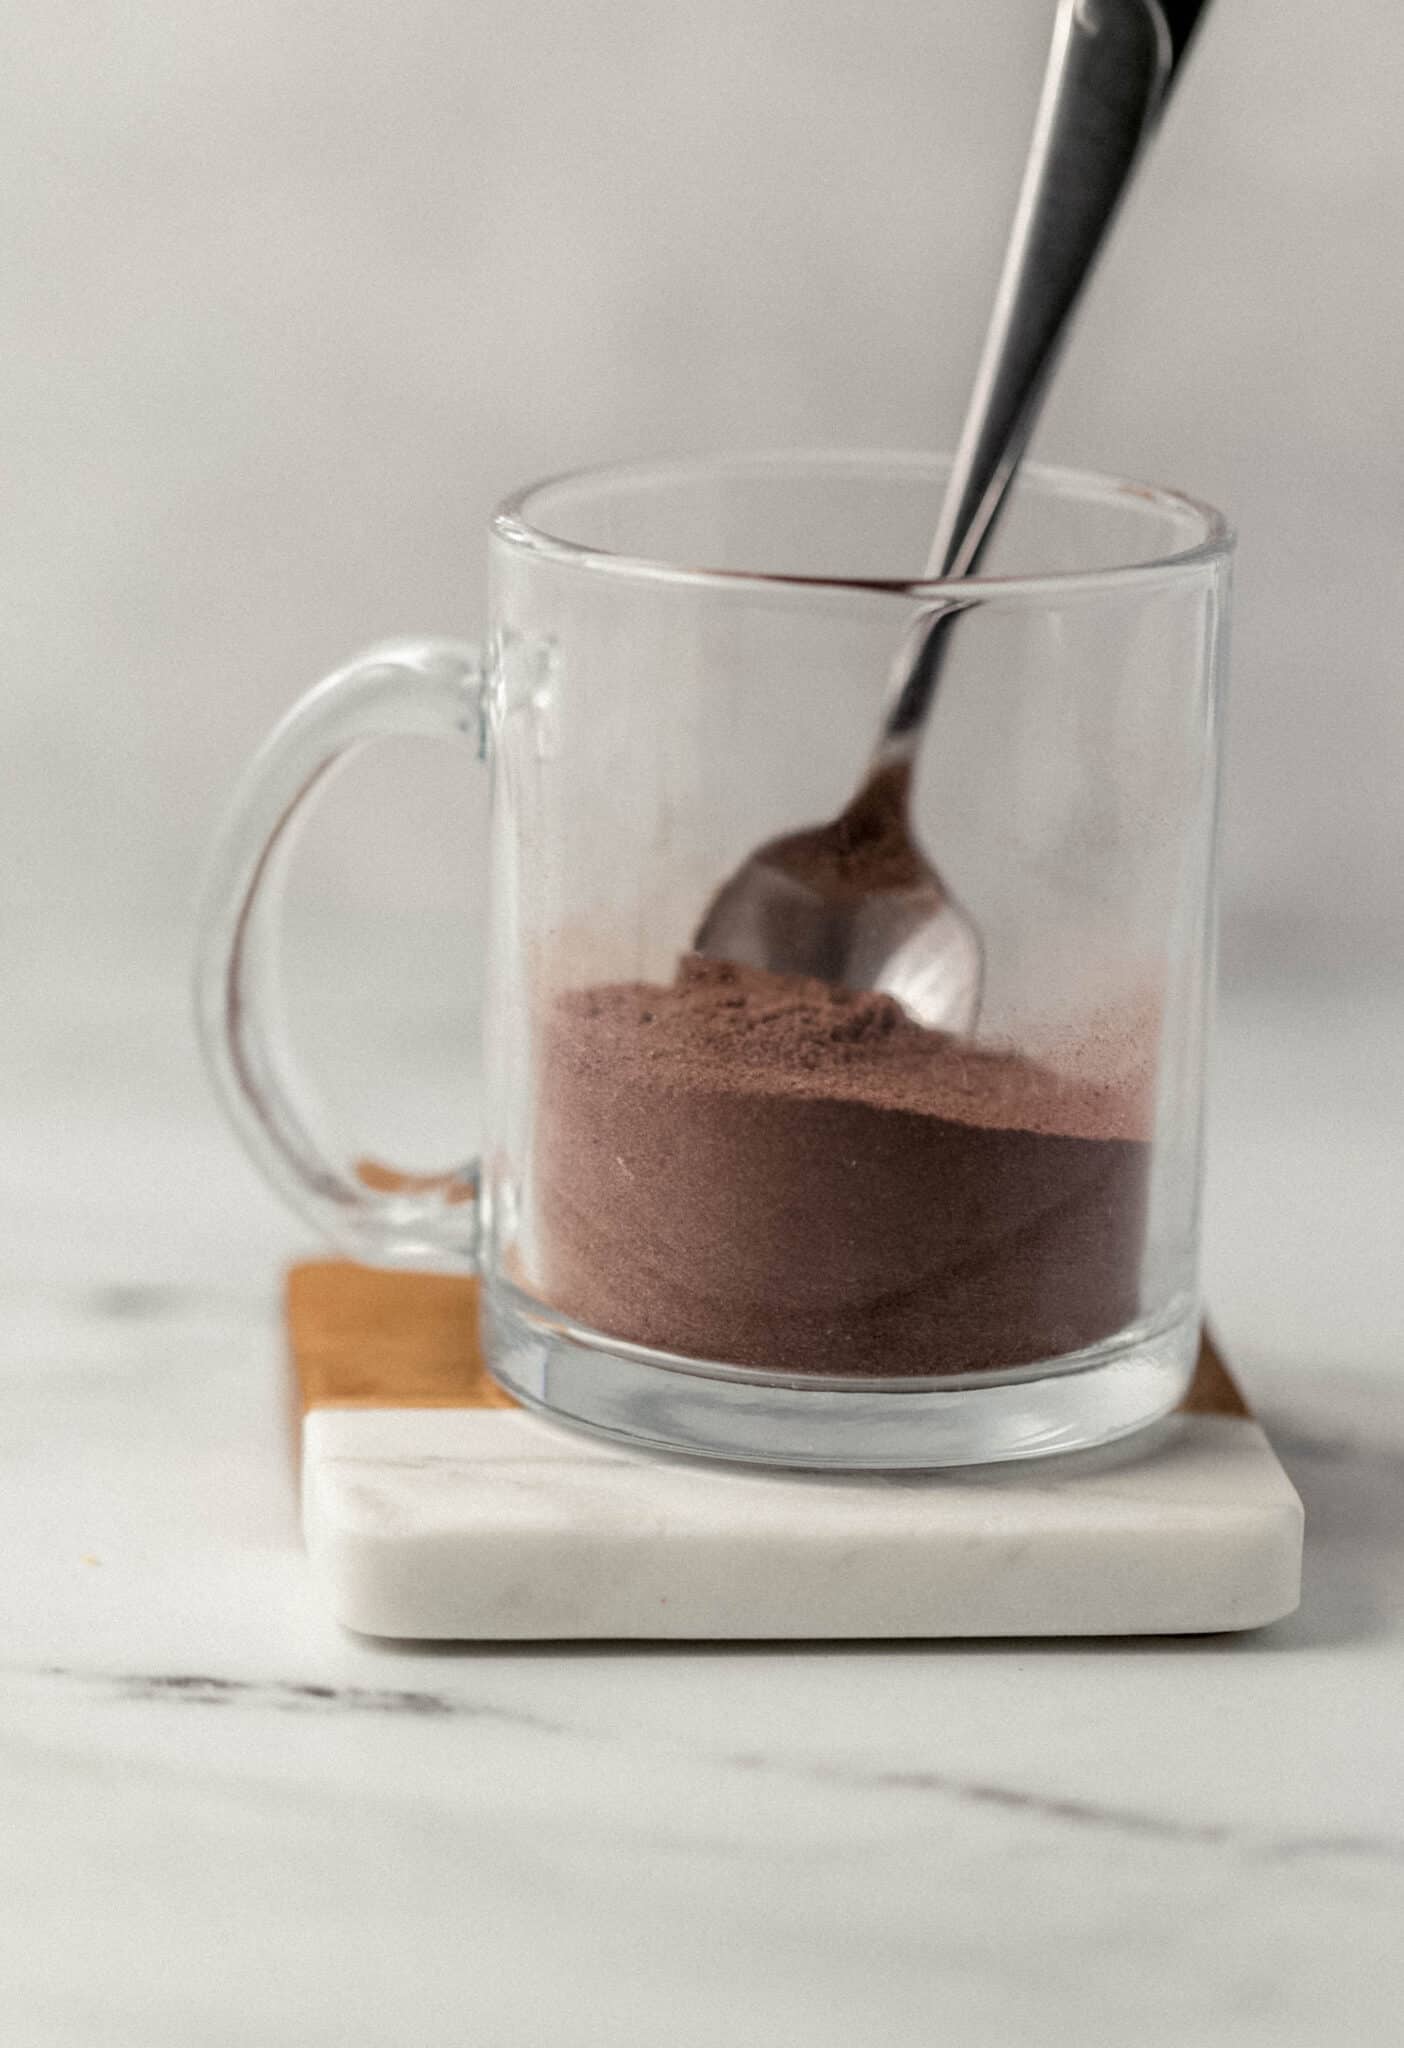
[199,453,1232,1468]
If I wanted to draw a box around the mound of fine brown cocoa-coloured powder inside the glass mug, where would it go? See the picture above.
[528,958,1148,1376]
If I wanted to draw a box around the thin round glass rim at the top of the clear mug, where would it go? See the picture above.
[489,446,1236,604]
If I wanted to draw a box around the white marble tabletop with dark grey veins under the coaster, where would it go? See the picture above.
[0,937,1404,2048]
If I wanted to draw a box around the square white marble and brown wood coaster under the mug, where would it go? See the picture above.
[289,1260,1302,1642]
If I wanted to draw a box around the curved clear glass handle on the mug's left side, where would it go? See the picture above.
[194,639,485,1272]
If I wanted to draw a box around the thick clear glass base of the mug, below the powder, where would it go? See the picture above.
[483,1280,1199,1473]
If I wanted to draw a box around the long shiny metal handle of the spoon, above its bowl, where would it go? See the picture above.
[880,0,1205,760]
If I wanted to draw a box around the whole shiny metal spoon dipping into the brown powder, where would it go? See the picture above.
[692,0,1208,1032]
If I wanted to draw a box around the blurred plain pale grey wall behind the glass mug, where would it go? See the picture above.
[0,0,1404,973]
